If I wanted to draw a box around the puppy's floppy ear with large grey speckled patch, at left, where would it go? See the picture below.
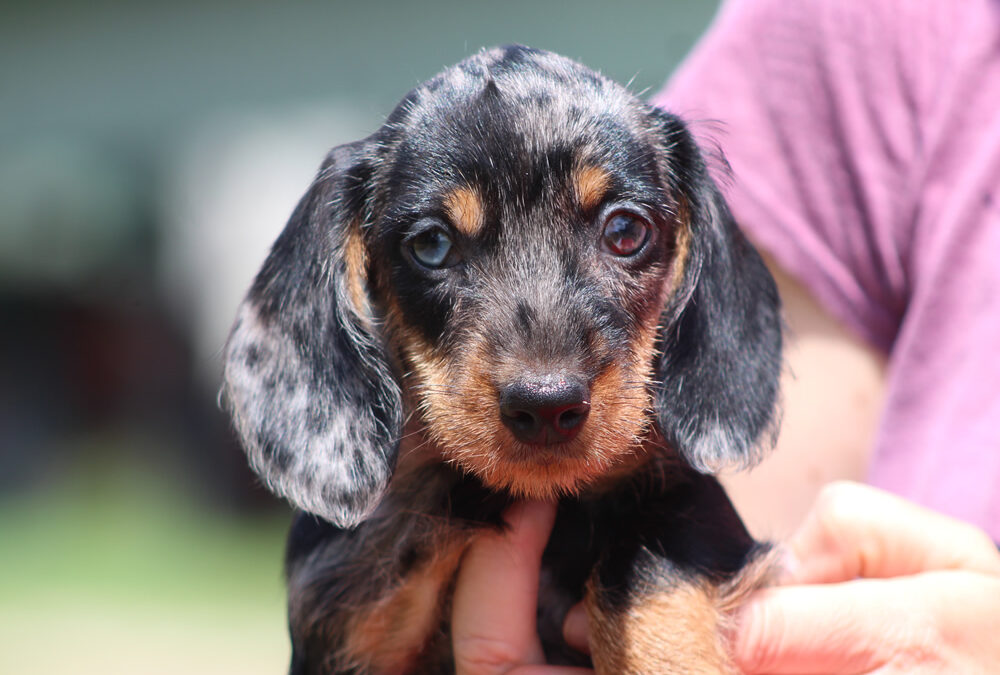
[223,141,402,527]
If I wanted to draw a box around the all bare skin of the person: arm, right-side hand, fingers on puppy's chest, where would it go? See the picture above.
[452,265,1000,675]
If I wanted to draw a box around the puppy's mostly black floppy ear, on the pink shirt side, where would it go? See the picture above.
[655,111,782,472]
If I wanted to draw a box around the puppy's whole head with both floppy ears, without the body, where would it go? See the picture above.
[224,47,781,526]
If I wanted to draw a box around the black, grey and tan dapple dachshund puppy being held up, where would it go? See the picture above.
[224,46,781,675]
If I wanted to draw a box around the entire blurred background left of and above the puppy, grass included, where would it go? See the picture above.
[0,0,717,675]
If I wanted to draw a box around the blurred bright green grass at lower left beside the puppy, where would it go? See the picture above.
[0,460,288,675]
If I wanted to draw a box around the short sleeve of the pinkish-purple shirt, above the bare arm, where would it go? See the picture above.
[654,0,952,351]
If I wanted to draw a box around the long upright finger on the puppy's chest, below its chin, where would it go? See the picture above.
[451,502,592,675]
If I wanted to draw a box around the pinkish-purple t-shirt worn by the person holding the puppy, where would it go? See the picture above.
[653,0,1000,540]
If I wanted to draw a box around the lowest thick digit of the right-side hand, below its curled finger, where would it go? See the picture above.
[733,571,1000,675]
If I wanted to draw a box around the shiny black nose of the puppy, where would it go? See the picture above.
[500,375,590,445]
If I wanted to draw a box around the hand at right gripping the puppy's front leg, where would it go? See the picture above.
[733,483,1000,675]
